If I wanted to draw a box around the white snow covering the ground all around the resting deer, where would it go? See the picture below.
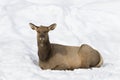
[0,0,120,80]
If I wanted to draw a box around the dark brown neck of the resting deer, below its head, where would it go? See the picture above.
[38,39,51,61]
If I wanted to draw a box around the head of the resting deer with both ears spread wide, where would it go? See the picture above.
[29,23,56,46]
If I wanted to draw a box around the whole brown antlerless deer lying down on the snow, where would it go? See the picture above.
[30,23,103,70]
